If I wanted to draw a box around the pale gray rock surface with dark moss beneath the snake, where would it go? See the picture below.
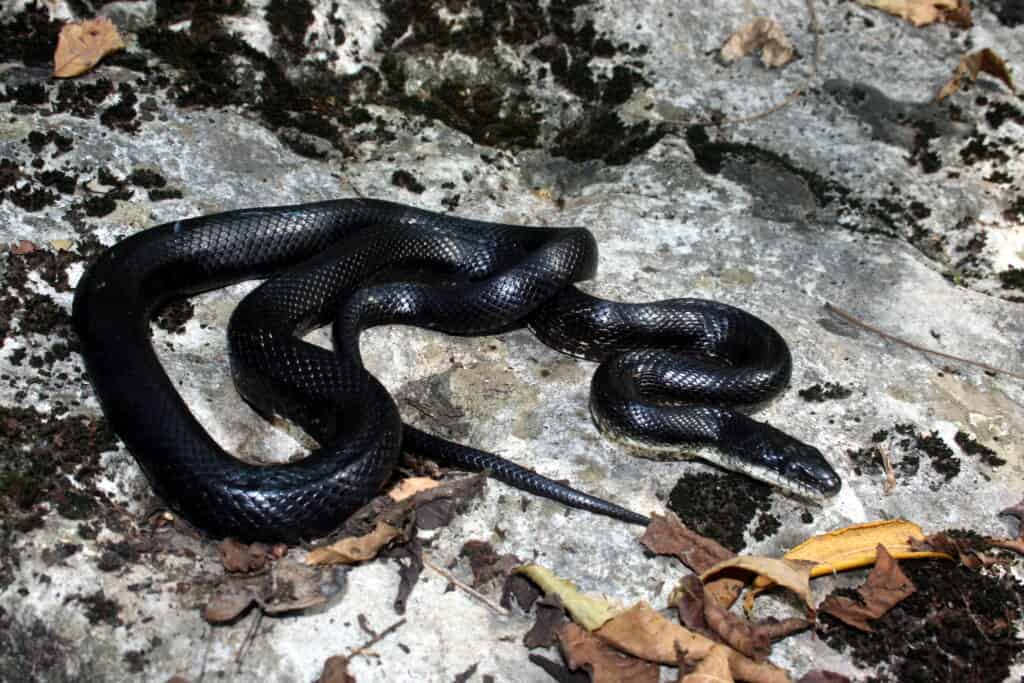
[0,0,1024,683]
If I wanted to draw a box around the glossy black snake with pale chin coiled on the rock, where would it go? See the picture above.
[73,200,840,541]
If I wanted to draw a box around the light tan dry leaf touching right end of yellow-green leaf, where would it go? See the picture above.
[596,600,790,683]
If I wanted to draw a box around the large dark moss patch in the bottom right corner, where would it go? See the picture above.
[818,560,1024,683]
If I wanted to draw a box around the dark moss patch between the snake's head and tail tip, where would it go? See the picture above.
[668,472,780,553]
